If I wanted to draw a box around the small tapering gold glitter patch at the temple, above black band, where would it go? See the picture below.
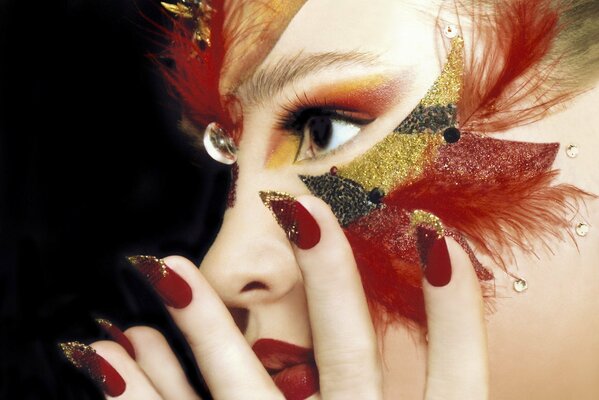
[420,37,464,107]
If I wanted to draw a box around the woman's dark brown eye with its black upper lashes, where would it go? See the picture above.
[278,106,374,162]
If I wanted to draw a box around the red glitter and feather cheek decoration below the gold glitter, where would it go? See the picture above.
[344,134,590,328]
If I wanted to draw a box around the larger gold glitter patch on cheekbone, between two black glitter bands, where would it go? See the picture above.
[337,133,444,193]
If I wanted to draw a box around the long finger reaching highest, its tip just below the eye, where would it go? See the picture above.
[294,196,382,399]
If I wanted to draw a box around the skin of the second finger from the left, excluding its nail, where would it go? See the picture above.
[125,326,200,400]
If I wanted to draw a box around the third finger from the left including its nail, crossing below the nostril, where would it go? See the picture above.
[130,256,281,400]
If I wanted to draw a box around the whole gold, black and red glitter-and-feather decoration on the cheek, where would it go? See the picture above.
[299,37,579,326]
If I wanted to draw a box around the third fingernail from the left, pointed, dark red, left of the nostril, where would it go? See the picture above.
[127,256,191,308]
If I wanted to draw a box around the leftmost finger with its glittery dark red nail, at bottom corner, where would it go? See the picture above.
[60,341,161,400]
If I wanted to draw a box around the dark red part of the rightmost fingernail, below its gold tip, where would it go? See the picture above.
[416,226,451,287]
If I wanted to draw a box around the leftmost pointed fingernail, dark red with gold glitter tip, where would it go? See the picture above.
[58,342,127,397]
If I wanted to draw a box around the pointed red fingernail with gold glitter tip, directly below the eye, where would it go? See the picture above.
[260,191,320,250]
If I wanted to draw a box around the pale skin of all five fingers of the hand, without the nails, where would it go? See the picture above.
[62,196,488,400]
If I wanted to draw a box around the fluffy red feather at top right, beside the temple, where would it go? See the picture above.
[458,0,577,134]
